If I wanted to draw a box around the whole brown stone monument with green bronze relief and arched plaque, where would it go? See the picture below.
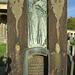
[8,0,67,75]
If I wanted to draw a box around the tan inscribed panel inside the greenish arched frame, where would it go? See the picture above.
[28,55,44,75]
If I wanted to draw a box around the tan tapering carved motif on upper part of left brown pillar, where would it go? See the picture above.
[9,0,24,38]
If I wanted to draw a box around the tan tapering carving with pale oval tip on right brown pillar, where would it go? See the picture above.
[51,0,65,53]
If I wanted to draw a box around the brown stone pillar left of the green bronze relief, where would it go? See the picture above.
[8,0,28,75]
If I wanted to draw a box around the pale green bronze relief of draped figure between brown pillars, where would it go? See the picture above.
[28,0,47,48]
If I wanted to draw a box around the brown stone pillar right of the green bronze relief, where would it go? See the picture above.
[48,0,67,75]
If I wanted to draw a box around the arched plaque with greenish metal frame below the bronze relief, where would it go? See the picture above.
[23,48,50,75]
